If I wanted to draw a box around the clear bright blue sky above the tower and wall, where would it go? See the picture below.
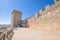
[0,0,54,24]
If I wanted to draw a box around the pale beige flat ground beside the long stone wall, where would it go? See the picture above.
[12,28,60,40]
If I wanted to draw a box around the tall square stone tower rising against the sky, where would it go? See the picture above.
[11,10,22,28]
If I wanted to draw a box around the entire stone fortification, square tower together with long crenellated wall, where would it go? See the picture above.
[11,0,60,33]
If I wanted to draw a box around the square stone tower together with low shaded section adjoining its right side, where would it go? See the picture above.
[11,10,26,29]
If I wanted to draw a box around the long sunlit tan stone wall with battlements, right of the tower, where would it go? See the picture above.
[27,0,60,33]
